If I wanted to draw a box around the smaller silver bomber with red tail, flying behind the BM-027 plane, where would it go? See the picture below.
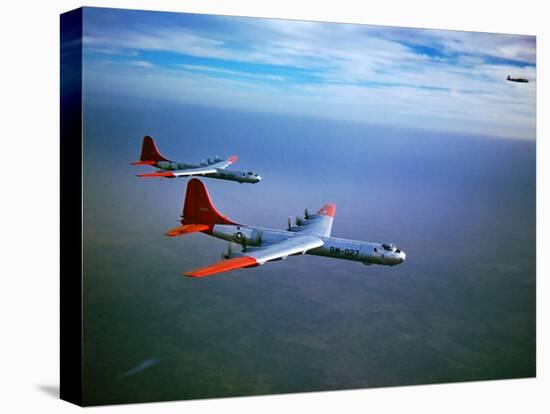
[131,135,262,184]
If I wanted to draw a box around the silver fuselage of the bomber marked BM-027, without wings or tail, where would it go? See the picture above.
[213,224,406,266]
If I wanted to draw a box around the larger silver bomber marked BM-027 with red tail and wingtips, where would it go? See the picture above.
[165,178,407,277]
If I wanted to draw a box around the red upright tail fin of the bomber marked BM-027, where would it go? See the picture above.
[181,178,237,227]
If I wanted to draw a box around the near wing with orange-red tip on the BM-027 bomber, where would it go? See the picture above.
[185,235,324,277]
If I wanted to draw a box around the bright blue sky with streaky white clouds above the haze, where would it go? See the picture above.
[84,8,536,140]
